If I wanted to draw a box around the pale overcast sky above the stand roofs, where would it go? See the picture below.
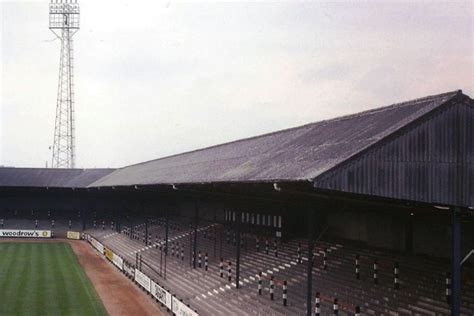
[0,0,474,167]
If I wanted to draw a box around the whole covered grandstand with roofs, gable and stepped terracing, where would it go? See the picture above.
[0,91,474,315]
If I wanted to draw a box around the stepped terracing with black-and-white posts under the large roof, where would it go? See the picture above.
[88,218,474,315]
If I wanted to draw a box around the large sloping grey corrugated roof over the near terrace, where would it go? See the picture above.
[90,91,458,186]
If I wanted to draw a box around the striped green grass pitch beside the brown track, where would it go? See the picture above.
[0,243,107,316]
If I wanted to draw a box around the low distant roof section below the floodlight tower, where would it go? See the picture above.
[0,167,115,188]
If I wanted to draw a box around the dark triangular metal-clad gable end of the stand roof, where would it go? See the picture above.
[314,94,474,207]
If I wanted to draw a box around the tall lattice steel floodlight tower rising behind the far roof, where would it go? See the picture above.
[49,0,79,168]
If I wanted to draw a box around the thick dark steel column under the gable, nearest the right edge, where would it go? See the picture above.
[451,207,461,316]
